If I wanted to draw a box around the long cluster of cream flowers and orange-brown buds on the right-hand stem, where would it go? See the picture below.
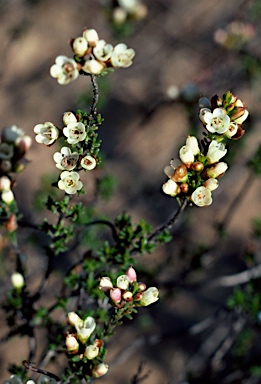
[162,92,248,207]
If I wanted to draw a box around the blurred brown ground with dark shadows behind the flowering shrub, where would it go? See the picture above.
[0,0,261,384]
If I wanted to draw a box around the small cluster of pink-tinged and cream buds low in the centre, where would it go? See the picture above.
[99,267,159,308]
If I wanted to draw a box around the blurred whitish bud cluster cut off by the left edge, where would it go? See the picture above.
[0,125,32,204]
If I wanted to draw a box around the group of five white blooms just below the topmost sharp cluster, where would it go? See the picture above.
[34,112,97,194]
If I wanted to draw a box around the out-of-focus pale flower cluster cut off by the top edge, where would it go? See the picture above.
[109,0,148,24]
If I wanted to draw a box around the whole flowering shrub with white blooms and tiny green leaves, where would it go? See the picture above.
[0,18,256,384]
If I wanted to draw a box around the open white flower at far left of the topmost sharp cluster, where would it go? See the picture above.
[50,56,79,85]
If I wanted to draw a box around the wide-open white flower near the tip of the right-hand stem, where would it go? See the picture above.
[204,108,230,134]
